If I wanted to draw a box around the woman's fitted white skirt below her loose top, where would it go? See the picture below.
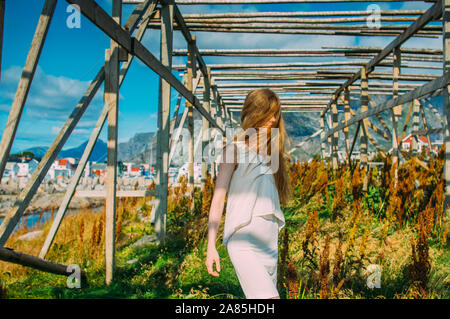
[227,214,279,299]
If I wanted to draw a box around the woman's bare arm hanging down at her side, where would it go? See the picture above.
[205,143,238,277]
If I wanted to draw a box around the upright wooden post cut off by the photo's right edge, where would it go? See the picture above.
[442,0,450,218]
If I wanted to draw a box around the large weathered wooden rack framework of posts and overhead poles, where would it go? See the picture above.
[0,0,450,284]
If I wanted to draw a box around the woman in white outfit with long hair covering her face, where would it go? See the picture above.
[205,89,292,299]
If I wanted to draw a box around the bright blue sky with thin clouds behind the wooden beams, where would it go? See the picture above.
[0,0,442,153]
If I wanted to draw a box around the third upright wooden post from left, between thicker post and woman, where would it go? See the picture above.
[186,36,197,210]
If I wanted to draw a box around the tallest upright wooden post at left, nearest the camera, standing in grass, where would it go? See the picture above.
[104,0,122,285]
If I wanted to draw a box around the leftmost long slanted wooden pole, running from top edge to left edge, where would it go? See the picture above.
[0,0,56,185]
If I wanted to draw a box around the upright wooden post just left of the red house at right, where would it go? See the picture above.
[390,47,402,185]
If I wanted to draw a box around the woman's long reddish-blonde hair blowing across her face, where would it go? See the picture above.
[230,88,292,205]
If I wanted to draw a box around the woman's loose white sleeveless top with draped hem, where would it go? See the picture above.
[223,141,285,247]
